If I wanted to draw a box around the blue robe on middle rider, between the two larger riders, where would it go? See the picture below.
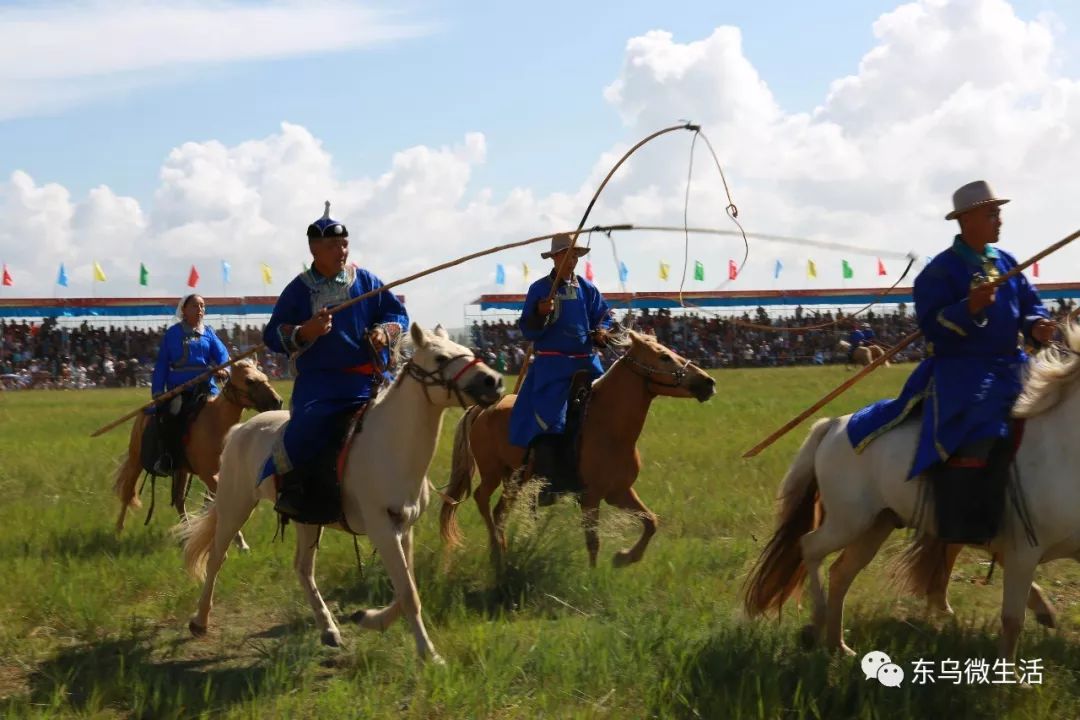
[510,271,611,448]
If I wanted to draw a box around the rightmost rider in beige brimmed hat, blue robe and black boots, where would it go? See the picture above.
[848,180,1055,543]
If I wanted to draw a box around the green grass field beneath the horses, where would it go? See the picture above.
[0,367,1080,719]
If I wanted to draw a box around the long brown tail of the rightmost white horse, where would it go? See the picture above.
[743,418,836,616]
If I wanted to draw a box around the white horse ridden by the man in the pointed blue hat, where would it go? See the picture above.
[177,324,502,662]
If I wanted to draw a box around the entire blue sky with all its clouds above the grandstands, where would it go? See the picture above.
[0,0,1080,322]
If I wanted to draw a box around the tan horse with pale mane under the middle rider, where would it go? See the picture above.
[441,332,716,567]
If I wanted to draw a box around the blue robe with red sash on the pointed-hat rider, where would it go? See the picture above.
[262,266,408,477]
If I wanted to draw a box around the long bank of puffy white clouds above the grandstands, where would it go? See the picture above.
[6,0,1080,326]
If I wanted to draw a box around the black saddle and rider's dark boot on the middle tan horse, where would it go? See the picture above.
[525,370,593,505]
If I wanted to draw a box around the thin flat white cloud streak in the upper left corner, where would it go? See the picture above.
[0,0,432,119]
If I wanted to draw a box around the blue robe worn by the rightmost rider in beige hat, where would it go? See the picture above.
[848,235,1050,477]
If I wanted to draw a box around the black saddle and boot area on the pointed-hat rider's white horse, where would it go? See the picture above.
[273,403,368,529]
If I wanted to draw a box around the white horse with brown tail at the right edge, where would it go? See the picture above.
[744,325,1080,657]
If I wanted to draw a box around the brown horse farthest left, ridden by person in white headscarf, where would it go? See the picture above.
[113,359,282,535]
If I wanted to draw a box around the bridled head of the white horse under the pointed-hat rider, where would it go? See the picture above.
[402,323,502,407]
